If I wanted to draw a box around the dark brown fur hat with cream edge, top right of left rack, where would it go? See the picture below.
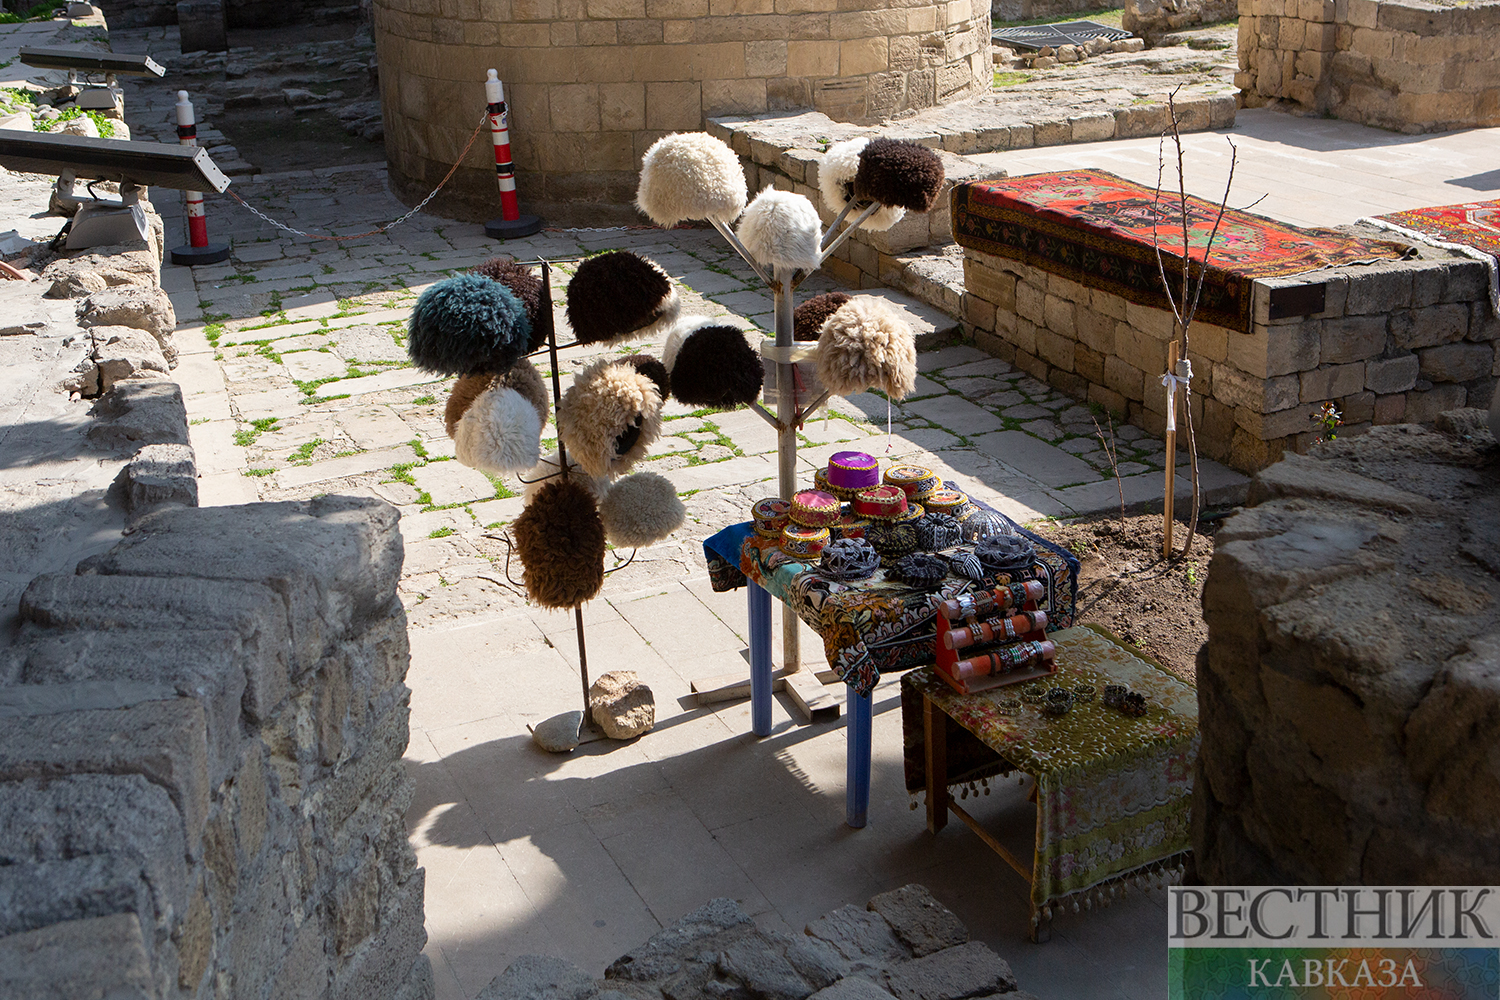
[567,250,681,343]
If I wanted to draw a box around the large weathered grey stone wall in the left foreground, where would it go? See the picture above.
[0,497,432,1000]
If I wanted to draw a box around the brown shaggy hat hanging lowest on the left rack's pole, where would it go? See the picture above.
[512,480,605,607]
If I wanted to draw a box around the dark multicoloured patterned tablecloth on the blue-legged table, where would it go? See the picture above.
[704,514,1079,694]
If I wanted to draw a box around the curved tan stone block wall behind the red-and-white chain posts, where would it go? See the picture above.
[375,0,992,225]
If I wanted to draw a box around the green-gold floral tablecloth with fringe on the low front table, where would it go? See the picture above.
[902,625,1199,909]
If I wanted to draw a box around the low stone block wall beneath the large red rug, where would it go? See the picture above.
[963,235,1500,472]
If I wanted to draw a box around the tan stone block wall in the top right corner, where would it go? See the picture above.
[1235,0,1500,132]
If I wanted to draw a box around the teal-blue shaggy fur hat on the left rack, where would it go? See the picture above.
[407,274,531,375]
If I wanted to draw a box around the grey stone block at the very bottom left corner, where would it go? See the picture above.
[0,913,159,1000]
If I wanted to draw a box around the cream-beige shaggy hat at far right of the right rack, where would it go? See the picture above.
[818,295,917,399]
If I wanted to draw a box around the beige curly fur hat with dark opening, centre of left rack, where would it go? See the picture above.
[558,358,662,477]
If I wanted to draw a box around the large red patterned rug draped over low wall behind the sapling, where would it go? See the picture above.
[953,169,1412,333]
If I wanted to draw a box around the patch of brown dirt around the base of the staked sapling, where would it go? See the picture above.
[1032,513,1220,684]
